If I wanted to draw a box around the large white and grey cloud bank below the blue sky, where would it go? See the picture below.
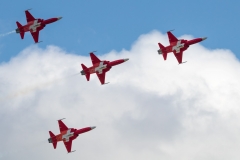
[0,31,240,160]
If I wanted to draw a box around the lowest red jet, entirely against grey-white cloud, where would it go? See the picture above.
[48,118,96,153]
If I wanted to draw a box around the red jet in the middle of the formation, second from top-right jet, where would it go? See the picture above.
[81,53,129,85]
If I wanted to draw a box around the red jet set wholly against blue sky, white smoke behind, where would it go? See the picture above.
[16,10,62,43]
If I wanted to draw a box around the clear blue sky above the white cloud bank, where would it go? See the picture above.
[0,0,240,62]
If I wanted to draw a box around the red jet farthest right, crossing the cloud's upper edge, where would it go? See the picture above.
[158,31,207,64]
